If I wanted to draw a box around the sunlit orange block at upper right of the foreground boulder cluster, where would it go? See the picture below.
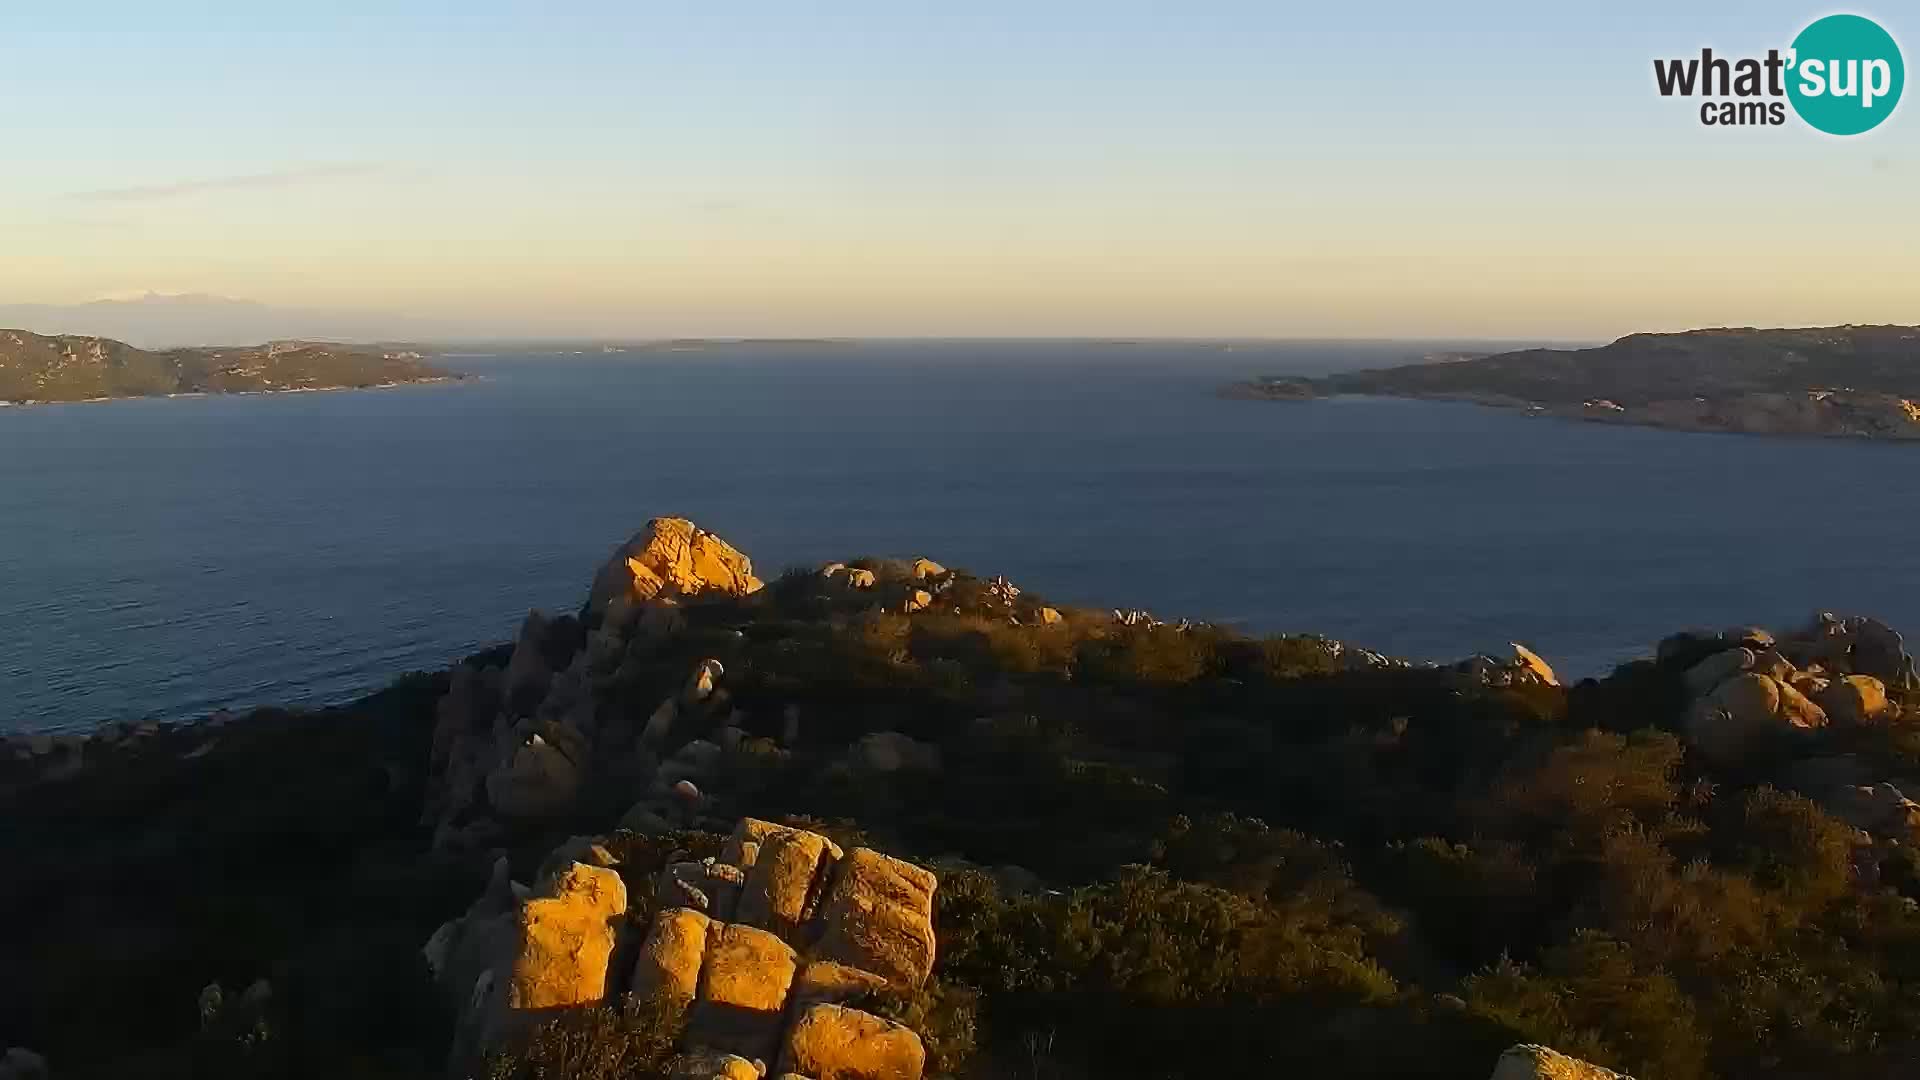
[814,847,939,986]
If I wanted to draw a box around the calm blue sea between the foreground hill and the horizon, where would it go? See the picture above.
[0,342,1920,730]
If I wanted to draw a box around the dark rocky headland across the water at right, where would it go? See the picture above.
[1223,327,1920,438]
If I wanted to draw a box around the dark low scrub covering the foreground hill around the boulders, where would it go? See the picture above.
[0,545,1920,1080]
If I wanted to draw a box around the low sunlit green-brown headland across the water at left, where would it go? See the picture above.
[0,331,455,404]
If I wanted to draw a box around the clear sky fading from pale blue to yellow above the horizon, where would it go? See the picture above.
[0,0,1920,340]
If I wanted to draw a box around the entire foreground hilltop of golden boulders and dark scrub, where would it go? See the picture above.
[0,519,1920,1080]
